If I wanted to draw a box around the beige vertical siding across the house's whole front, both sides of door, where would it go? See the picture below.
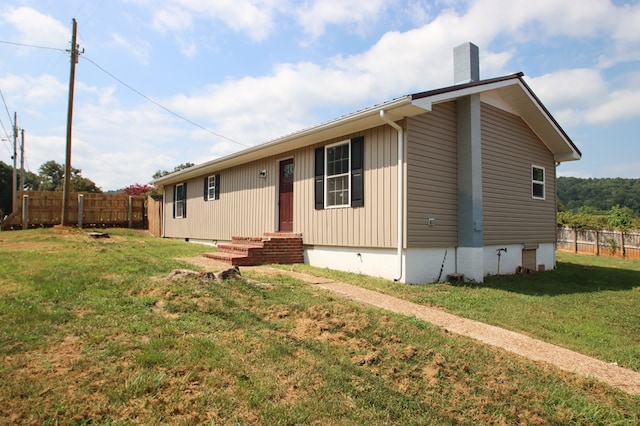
[165,126,398,247]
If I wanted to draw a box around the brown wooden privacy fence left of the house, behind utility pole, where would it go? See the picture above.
[3,191,146,229]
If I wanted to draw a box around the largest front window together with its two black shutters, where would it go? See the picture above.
[314,136,364,210]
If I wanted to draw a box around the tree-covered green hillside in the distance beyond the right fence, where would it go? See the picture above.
[558,177,640,215]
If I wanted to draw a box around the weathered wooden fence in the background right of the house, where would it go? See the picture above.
[558,228,640,259]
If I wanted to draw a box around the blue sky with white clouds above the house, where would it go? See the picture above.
[0,0,640,191]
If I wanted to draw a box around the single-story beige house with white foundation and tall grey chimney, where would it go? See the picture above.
[156,43,581,283]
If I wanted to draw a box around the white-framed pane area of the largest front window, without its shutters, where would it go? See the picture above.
[325,142,350,207]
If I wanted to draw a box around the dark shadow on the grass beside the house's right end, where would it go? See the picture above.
[478,261,640,296]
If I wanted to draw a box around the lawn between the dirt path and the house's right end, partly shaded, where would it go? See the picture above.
[284,252,640,371]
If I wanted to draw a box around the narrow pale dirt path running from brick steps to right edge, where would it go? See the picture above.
[184,264,640,395]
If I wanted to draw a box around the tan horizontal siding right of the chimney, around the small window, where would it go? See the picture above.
[481,103,556,245]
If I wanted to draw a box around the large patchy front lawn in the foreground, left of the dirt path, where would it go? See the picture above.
[0,229,640,425]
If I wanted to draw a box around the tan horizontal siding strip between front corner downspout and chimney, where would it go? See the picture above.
[407,102,458,247]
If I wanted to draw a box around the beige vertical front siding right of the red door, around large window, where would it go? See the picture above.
[293,126,398,247]
